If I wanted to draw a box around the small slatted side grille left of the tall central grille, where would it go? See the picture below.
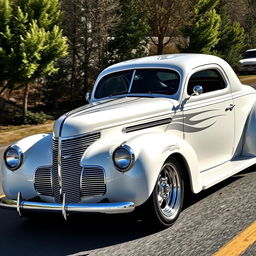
[35,167,53,196]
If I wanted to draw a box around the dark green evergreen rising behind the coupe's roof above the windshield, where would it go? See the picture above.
[108,0,149,63]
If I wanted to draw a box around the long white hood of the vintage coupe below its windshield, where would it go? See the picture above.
[53,97,178,137]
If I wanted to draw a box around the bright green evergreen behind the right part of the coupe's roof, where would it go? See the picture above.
[183,0,221,54]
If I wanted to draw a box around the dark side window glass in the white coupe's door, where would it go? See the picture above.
[187,69,226,95]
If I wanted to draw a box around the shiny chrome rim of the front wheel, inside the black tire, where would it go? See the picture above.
[156,162,183,220]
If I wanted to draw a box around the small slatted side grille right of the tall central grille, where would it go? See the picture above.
[81,166,106,196]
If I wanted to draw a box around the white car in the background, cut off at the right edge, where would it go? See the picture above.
[237,49,256,75]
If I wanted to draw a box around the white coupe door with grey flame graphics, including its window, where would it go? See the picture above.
[183,65,234,172]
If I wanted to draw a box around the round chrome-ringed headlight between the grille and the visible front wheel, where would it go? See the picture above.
[113,145,135,172]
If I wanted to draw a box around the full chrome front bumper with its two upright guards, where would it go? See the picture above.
[0,192,135,219]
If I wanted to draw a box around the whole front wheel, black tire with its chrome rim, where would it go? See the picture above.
[142,157,184,228]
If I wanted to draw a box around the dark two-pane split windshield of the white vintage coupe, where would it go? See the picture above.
[94,69,180,99]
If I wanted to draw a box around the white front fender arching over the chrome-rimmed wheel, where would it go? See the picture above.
[127,133,202,194]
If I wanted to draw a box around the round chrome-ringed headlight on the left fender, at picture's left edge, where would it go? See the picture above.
[4,145,23,171]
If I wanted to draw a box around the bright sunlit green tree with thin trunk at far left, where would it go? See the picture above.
[0,0,67,115]
